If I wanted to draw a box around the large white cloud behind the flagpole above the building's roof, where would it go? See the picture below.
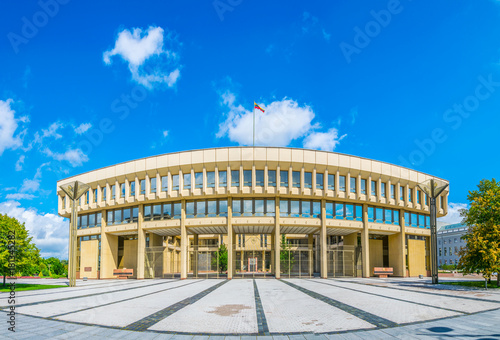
[217,91,343,150]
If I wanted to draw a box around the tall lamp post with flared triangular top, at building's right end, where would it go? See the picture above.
[417,178,448,284]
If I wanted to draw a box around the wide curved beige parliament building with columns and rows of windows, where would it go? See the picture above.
[57,147,448,279]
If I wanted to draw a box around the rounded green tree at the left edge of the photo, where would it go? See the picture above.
[0,214,40,286]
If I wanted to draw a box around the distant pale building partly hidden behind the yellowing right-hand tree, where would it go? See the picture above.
[437,223,468,267]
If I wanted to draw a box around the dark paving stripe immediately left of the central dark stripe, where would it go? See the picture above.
[123,280,228,332]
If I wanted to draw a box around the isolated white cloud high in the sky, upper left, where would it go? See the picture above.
[103,26,180,88]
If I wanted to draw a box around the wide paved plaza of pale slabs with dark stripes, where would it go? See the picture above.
[0,278,500,340]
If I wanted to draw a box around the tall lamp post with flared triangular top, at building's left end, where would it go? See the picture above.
[61,181,90,287]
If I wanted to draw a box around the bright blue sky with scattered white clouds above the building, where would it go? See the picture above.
[0,0,500,257]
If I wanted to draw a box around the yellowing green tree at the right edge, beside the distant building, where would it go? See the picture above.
[458,179,500,286]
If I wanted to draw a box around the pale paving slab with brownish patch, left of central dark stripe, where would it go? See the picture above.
[149,279,258,334]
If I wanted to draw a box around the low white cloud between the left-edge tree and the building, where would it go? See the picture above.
[0,201,69,259]
